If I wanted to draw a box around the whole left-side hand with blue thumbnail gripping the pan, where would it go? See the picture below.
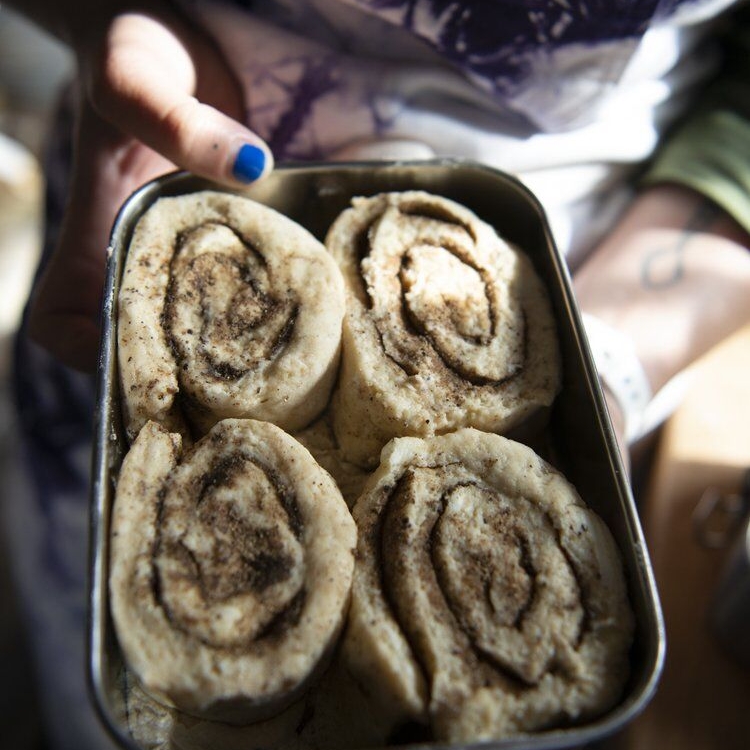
[29,5,273,371]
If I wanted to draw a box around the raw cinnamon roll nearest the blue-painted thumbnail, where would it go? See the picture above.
[118,191,344,439]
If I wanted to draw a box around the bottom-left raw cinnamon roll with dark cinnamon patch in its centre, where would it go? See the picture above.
[110,419,356,723]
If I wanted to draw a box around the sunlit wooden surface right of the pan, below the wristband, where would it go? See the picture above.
[612,325,750,750]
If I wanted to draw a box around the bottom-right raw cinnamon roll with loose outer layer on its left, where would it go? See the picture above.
[343,428,633,742]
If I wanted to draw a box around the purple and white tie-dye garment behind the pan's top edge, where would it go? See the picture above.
[182,0,731,262]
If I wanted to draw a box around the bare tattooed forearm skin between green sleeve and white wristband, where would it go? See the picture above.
[575,185,750,392]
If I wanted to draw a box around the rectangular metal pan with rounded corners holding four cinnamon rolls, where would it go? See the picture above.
[88,160,665,750]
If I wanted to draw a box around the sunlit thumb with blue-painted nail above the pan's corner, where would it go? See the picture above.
[91,15,273,185]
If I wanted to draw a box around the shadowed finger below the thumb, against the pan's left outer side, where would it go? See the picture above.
[29,97,174,372]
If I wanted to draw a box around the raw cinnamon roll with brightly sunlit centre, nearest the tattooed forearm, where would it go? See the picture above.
[325,191,560,467]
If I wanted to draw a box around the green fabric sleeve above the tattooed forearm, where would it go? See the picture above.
[642,5,750,231]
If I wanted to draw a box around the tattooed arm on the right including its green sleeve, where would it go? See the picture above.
[575,6,750,440]
